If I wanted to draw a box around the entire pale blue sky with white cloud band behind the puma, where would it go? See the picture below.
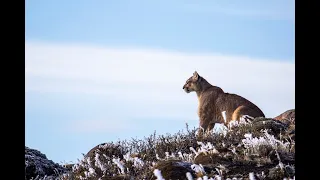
[25,0,295,162]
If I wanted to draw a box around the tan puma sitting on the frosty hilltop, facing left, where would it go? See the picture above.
[183,72,265,131]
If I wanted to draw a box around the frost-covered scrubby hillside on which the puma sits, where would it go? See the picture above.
[56,118,295,180]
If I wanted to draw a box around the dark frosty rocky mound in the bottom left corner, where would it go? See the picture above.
[25,146,67,180]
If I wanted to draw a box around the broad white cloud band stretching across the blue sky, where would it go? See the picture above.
[25,42,295,129]
